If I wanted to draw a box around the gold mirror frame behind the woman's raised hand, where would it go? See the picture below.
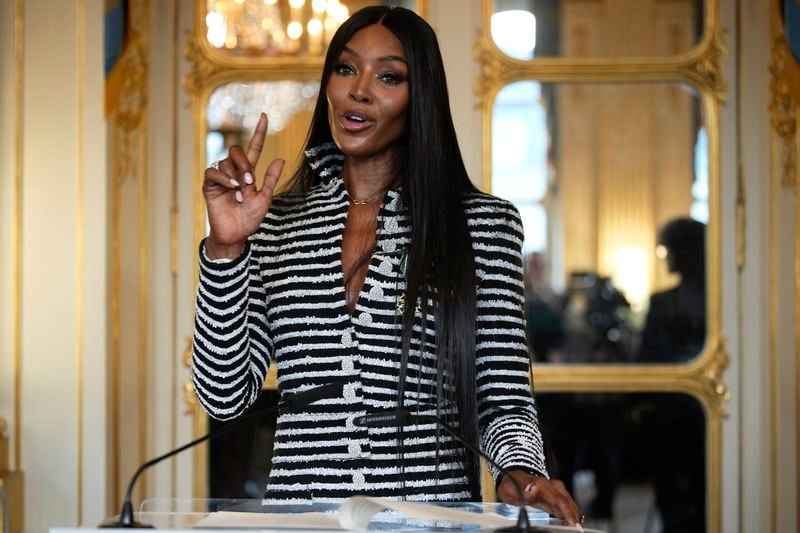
[182,0,428,498]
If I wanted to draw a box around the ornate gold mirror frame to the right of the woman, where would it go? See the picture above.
[474,0,730,532]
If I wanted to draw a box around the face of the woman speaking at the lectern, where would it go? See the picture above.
[325,24,408,158]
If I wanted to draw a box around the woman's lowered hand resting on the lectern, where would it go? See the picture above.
[497,470,583,529]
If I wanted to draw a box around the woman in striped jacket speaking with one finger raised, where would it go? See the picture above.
[193,7,580,524]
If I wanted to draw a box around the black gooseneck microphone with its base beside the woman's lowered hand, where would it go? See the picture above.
[353,410,546,532]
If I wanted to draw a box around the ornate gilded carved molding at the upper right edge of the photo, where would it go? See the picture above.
[769,32,797,191]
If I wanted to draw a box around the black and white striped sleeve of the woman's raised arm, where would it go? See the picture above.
[192,241,272,420]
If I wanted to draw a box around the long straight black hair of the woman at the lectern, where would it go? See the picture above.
[290,6,480,497]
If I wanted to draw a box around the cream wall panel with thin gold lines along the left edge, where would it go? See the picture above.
[0,0,107,531]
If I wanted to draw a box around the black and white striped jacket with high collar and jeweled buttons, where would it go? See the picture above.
[192,145,546,503]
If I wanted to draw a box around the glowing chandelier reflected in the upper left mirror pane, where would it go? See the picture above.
[206,0,350,56]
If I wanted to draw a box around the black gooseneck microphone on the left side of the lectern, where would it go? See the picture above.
[99,381,344,529]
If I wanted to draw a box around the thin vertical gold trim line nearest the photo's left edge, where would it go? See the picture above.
[13,0,25,470]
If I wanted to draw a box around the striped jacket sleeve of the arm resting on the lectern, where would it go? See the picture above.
[472,199,547,481]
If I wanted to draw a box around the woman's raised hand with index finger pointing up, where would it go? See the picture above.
[203,113,284,259]
